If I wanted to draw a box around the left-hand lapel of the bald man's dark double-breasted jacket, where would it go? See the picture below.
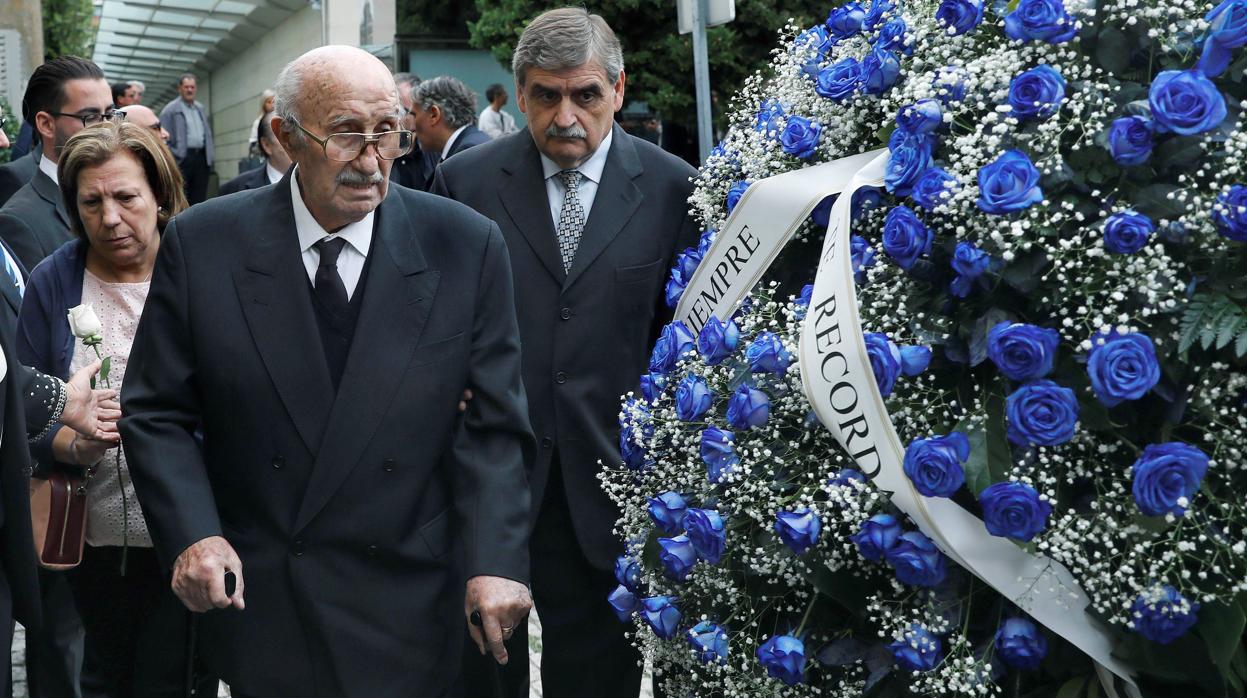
[234,177,333,454]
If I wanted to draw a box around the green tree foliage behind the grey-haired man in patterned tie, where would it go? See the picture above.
[470,0,835,125]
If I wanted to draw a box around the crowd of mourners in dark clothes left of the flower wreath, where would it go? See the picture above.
[0,7,698,698]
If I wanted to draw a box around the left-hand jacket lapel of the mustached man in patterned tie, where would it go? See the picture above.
[498,135,566,282]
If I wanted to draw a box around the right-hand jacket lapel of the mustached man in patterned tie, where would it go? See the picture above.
[566,126,645,290]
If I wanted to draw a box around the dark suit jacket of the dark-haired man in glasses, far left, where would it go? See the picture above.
[0,170,74,269]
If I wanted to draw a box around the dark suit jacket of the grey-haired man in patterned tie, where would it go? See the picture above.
[433,126,698,570]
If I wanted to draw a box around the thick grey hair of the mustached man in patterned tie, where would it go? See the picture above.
[511,7,624,86]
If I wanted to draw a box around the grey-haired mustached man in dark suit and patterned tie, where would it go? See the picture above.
[433,7,697,698]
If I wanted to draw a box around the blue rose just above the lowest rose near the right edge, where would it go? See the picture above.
[1131,441,1208,516]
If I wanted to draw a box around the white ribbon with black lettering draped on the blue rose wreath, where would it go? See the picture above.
[676,148,1140,698]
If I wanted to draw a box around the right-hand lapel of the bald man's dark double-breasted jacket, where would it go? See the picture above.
[294,191,440,531]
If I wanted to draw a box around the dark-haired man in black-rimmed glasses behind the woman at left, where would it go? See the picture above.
[0,56,113,269]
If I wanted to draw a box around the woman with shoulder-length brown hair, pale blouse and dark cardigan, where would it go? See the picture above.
[17,122,216,698]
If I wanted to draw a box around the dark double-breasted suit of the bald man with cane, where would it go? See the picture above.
[121,176,532,698]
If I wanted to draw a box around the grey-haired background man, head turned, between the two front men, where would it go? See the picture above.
[412,75,489,172]
